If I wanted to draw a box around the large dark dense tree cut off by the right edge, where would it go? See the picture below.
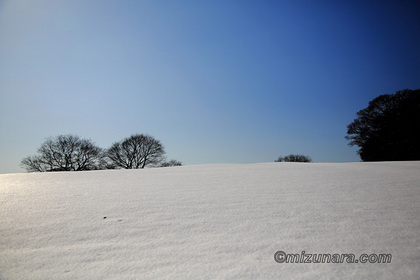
[345,89,420,161]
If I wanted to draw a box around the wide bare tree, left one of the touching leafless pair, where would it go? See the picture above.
[21,135,106,172]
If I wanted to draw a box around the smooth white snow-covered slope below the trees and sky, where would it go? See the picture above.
[0,162,420,280]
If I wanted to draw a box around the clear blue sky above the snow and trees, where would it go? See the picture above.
[0,0,420,173]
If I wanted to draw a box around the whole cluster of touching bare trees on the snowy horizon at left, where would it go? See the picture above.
[21,134,182,172]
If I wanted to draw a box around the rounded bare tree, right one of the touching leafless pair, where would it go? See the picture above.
[107,134,165,169]
